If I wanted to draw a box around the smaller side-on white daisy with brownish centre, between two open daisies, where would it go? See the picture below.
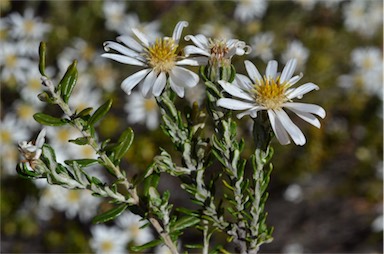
[184,34,251,67]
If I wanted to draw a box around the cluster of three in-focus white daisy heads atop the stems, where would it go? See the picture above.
[102,21,325,145]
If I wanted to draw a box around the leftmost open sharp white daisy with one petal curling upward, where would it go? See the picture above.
[102,21,199,97]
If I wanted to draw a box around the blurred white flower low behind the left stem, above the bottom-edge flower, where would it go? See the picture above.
[116,212,153,245]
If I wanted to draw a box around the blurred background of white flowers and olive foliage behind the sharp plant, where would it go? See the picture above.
[0,0,383,253]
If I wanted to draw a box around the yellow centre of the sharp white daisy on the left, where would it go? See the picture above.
[146,38,178,73]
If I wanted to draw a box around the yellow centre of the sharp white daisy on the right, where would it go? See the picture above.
[254,77,288,109]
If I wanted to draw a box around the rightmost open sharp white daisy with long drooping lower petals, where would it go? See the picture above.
[217,59,325,145]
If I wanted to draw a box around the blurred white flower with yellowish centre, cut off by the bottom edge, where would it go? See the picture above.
[89,225,128,254]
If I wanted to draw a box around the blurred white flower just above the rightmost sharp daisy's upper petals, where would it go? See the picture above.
[281,40,309,71]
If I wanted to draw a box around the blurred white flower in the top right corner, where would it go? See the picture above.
[343,0,383,37]
